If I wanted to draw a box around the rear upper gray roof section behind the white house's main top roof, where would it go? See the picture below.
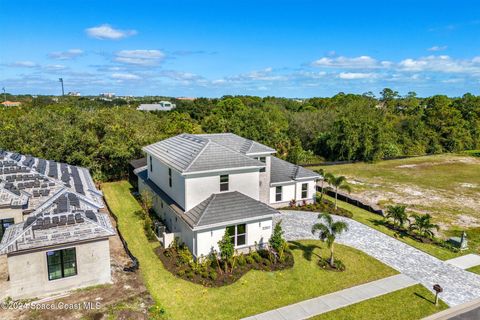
[197,133,276,155]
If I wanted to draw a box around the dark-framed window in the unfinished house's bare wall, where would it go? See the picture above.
[47,248,77,280]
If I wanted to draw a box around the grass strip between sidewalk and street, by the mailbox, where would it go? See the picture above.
[311,284,447,320]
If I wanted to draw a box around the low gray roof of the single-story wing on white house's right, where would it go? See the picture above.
[270,156,320,183]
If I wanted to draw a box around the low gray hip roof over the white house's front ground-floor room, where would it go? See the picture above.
[181,191,278,228]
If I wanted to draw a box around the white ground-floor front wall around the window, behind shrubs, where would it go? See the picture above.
[196,218,272,257]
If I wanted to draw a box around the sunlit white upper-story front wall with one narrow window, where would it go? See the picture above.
[185,169,259,211]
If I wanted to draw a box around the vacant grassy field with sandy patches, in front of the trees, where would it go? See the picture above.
[310,154,480,229]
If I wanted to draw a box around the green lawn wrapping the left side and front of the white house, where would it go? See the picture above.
[102,181,398,319]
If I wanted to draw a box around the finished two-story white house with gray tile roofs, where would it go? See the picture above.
[135,133,320,257]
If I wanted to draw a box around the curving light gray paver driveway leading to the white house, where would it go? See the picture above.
[274,211,480,306]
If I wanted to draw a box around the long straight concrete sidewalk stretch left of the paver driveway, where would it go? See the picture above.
[244,274,418,320]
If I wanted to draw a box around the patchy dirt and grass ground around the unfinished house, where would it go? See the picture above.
[0,215,153,320]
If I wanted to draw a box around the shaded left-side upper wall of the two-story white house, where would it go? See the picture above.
[147,154,185,208]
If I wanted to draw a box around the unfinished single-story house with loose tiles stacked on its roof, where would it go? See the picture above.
[0,150,115,299]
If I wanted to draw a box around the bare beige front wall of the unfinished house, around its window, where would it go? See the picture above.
[7,239,111,299]
